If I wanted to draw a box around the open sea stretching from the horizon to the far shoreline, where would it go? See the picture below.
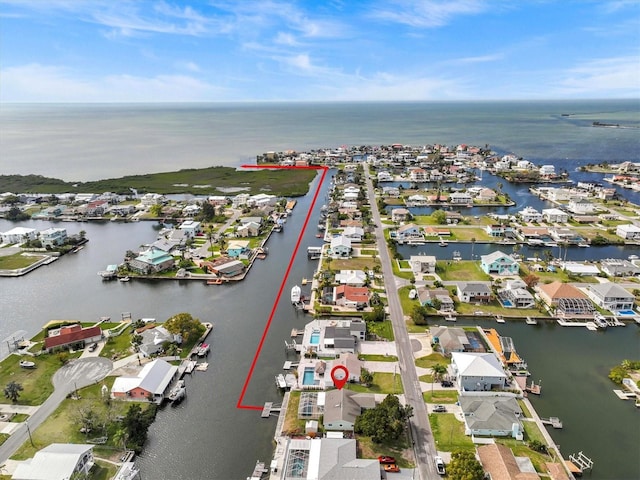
[0,99,640,181]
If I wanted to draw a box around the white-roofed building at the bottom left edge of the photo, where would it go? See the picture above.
[11,443,95,480]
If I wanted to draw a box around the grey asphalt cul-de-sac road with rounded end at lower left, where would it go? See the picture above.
[0,357,113,464]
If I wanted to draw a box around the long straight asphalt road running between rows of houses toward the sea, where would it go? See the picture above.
[365,167,440,480]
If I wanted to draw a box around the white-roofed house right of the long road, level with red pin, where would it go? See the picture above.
[451,352,507,392]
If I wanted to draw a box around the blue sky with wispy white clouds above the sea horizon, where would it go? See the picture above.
[0,0,640,102]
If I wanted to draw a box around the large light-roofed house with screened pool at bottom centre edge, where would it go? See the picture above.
[282,438,382,480]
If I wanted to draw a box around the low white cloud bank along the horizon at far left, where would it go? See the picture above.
[0,64,230,103]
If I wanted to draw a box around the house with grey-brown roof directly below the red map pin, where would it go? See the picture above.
[322,388,376,432]
